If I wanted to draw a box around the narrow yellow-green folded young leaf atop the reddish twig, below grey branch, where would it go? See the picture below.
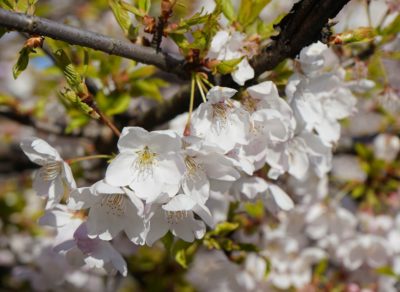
[54,49,86,93]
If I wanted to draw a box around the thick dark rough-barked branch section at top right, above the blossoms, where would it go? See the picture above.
[250,0,350,77]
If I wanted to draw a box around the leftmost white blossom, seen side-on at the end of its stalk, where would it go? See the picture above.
[21,137,76,209]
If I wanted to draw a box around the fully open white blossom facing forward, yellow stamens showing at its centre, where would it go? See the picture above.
[105,127,185,202]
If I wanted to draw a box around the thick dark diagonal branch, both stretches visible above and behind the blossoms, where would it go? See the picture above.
[144,0,349,129]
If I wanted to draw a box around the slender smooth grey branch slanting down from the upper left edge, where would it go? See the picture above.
[0,8,187,78]
